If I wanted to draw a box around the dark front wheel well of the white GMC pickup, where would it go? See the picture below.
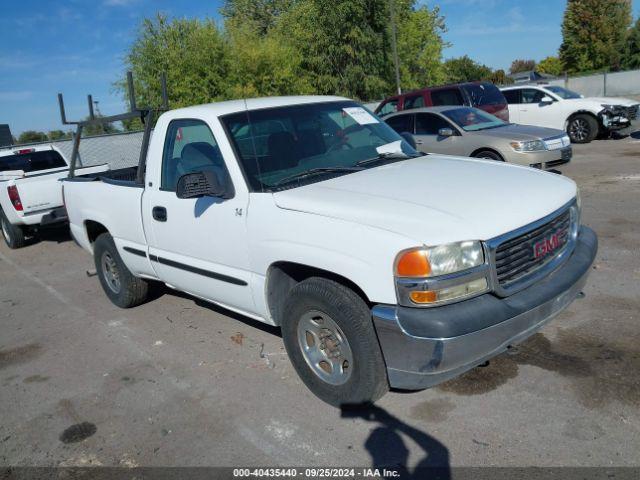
[266,262,371,325]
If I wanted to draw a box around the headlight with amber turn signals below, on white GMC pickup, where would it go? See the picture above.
[394,241,489,307]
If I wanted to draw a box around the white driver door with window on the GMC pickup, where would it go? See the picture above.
[142,119,255,312]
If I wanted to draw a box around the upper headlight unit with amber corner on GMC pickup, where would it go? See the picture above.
[395,241,484,277]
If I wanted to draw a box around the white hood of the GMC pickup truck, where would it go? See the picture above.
[273,155,576,245]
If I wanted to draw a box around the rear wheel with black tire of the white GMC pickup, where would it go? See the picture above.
[93,233,149,308]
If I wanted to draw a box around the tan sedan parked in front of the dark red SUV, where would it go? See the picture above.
[384,107,572,169]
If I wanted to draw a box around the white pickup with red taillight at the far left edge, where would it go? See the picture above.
[0,145,108,248]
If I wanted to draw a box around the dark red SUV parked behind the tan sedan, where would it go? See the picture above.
[375,82,509,122]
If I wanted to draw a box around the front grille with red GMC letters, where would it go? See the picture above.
[495,209,571,287]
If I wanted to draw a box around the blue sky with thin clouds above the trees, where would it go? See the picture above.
[0,0,640,135]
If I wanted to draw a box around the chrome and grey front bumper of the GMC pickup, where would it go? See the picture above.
[372,226,598,390]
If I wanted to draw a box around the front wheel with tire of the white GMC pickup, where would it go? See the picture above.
[282,277,389,407]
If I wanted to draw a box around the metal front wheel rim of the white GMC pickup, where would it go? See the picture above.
[298,310,353,385]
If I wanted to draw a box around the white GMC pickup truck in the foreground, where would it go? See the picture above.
[64,96,597,405]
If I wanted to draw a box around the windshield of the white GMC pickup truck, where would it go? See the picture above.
[222,101,419,192]
